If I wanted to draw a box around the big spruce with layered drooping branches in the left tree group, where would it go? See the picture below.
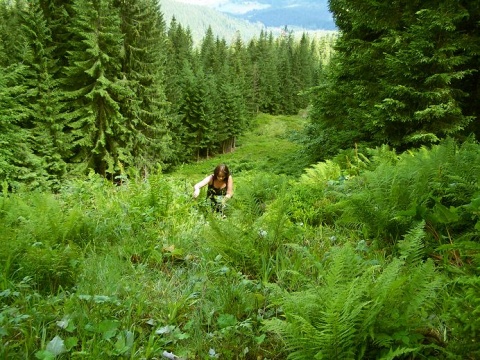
[63,0,137,176]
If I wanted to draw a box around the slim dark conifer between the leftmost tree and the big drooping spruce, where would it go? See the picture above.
[20,0,69,187]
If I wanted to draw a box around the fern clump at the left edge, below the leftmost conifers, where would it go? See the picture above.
[0,193,82,294]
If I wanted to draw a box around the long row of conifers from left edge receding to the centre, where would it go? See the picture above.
[0,0,334,189]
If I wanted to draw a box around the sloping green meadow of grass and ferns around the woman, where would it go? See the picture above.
[0,115,480,360]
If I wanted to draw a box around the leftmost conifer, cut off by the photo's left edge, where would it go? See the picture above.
[0,1,58,188]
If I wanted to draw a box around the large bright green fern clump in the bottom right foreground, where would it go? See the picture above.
[266,233,442,360]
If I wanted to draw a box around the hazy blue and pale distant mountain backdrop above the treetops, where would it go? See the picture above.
[159,0,332,44]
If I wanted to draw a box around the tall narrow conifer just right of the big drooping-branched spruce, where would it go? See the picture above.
[118,0,172,168]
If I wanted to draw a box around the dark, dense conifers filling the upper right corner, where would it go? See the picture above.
[308,0,480,159]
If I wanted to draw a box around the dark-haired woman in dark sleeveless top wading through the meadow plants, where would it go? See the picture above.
[193,164,233,212]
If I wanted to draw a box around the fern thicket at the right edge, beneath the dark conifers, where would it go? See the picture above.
[330,140,480,250]
